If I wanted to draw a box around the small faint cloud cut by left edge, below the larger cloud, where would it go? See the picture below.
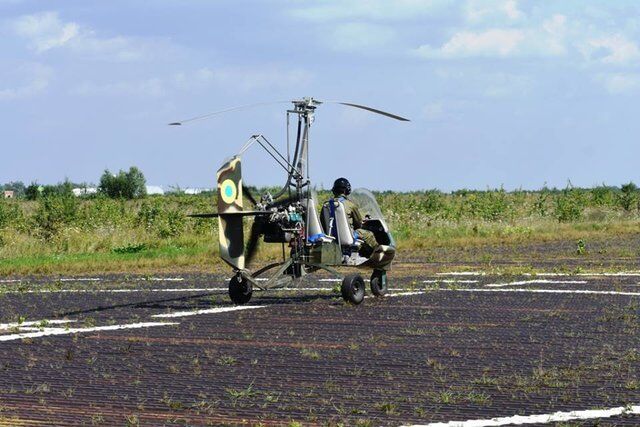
[0,64,53,101]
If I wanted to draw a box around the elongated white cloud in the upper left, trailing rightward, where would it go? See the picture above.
[12,12,172,62]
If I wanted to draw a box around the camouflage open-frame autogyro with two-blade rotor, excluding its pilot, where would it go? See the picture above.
[170,97,409,304]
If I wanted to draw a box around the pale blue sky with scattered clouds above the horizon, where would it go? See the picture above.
[0,0,640,191]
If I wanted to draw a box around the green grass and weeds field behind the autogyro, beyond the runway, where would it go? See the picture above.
[0,187,640,276]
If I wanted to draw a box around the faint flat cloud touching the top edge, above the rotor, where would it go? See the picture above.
[291,0,455,22]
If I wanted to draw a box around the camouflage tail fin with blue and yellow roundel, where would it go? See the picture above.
[217,156,244,270]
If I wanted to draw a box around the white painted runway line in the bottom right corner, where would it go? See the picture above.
[404,405,640,427]
